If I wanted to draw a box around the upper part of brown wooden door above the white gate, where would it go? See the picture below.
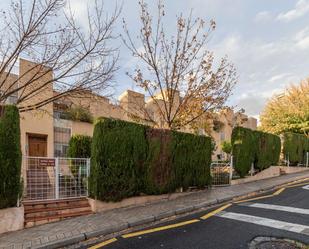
[28,134,47,157]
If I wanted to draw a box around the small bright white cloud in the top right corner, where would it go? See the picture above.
[277,0,309,22]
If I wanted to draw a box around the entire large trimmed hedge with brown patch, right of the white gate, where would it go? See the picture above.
[89,119,211,201]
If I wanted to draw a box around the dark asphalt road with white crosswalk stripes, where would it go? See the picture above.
[88,182,309,249]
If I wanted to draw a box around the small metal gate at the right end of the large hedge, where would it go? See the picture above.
[210,158,233,186]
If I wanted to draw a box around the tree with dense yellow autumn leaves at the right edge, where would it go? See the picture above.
[261,79,309,137]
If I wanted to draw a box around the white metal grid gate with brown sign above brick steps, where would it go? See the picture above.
[23,157,90,200]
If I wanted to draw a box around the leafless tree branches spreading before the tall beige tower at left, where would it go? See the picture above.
[0,0,121,112]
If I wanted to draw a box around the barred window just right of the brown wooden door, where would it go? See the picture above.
[54,127,71,157]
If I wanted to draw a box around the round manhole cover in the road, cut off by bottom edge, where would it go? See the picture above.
[249,237,308,249]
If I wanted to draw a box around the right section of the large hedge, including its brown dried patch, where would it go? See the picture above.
[143,128,211,194]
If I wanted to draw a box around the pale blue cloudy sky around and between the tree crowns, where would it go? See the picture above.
[2,0,309,119]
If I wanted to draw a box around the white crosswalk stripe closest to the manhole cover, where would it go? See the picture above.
[216,211,309,235]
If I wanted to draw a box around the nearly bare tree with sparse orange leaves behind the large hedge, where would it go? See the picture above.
[122,0,237,129]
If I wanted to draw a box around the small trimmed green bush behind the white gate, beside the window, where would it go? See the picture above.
[67,135,92,158]
